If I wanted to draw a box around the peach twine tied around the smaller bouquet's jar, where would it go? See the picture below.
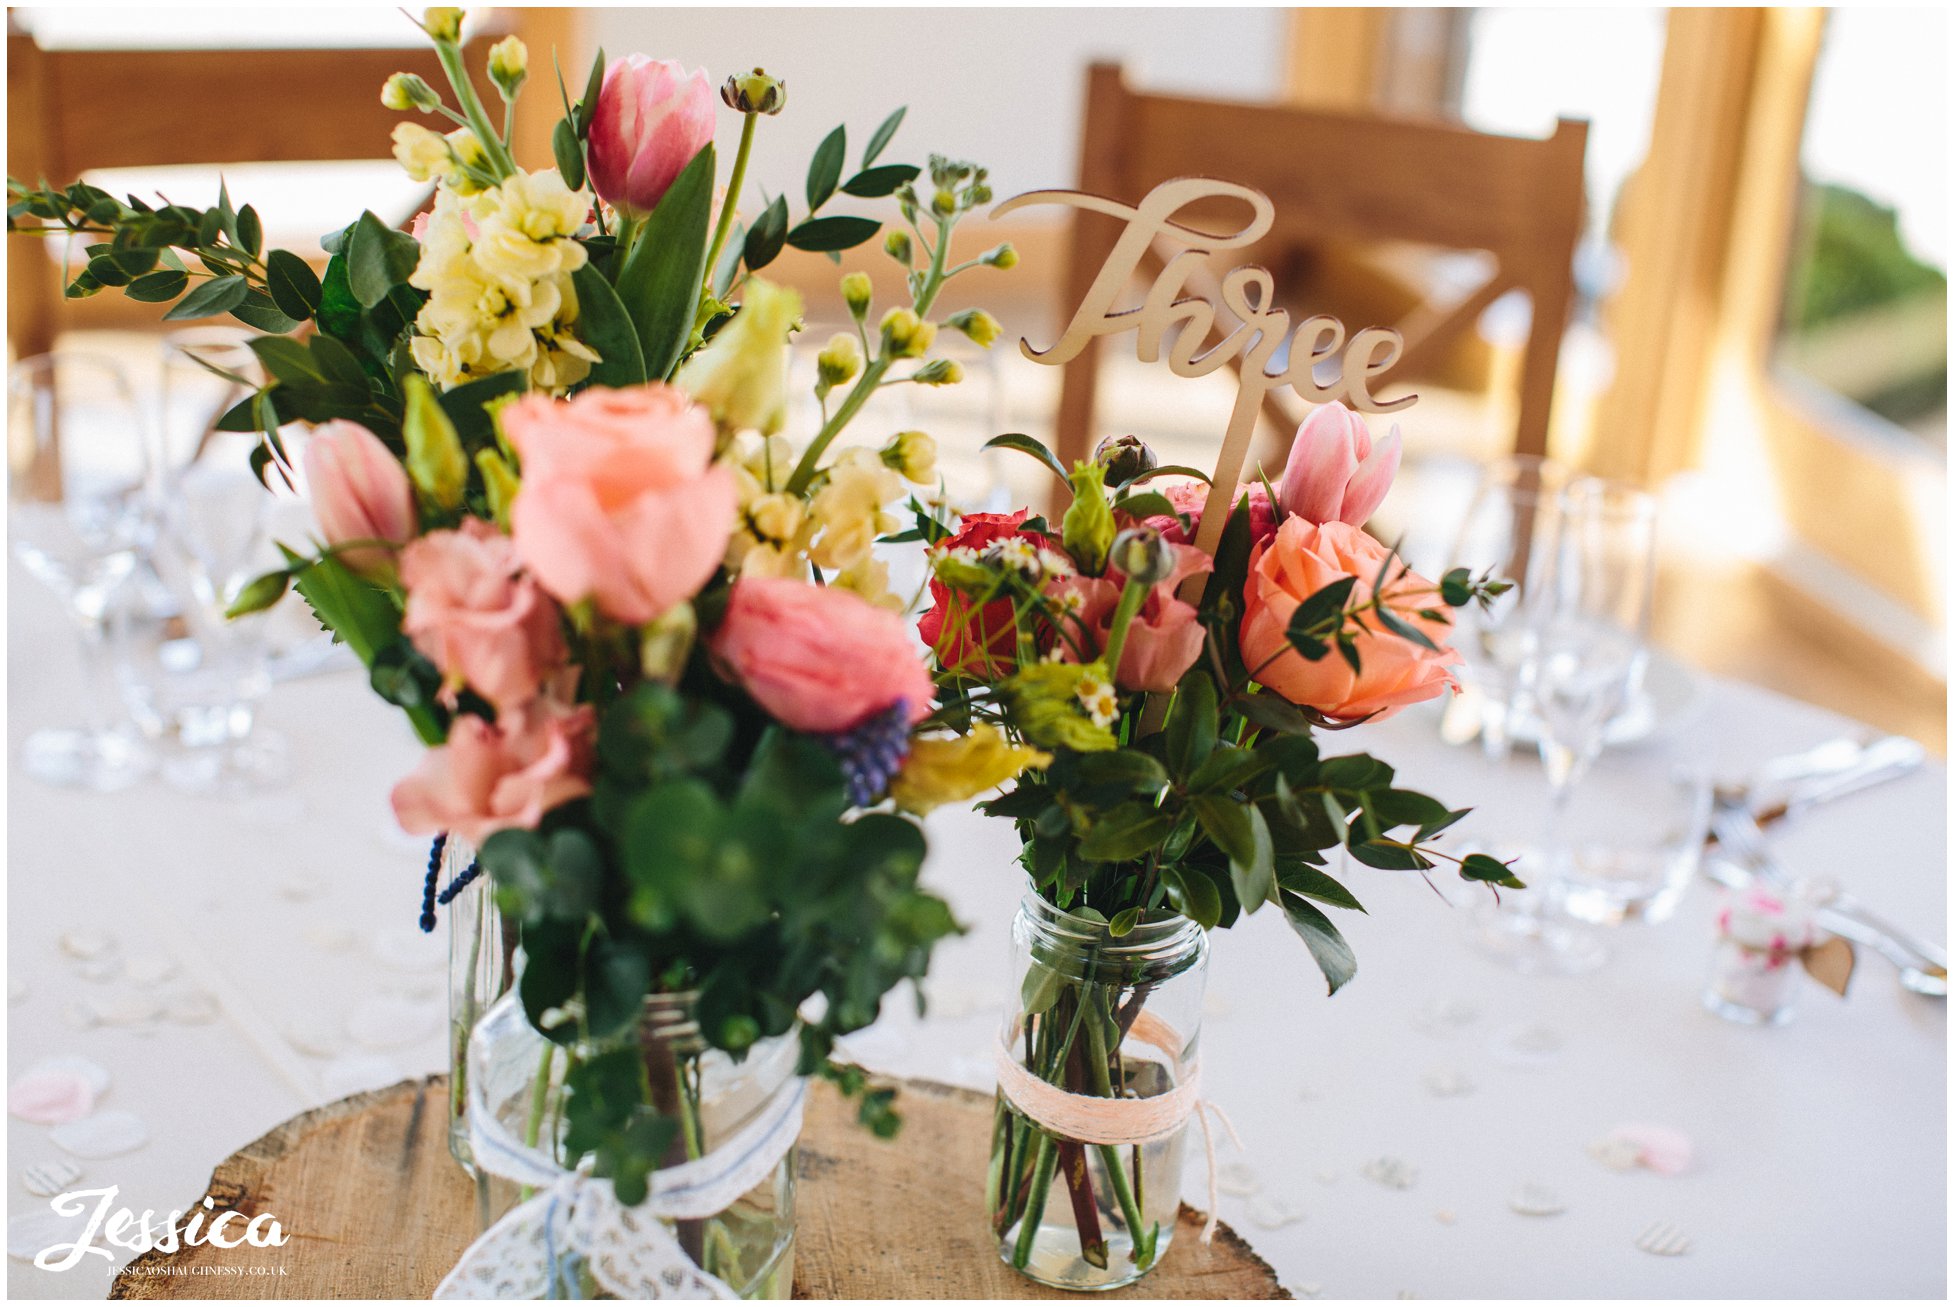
[997,1012,1241,1243]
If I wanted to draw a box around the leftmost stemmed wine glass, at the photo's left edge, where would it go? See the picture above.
[8,350,154,791]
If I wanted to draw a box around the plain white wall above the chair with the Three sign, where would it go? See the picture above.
[584,6,1288,207]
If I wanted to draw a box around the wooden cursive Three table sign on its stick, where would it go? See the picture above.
[993,178,1419,604]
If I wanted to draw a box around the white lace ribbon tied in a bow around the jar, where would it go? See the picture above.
[434,994,807,1301]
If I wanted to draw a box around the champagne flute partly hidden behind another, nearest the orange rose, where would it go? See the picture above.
[1440,453,1569,762]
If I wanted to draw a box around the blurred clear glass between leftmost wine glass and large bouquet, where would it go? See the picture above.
[115,328,285,795]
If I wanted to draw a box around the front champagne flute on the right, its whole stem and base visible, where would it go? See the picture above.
[1483,477,1657,975]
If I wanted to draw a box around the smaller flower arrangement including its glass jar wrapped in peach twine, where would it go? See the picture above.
[920,402,1520,1287]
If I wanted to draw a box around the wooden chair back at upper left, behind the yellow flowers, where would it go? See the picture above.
[6,10,571,358]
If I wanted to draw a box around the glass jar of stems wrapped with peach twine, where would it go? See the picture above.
[985,895,1208,1289]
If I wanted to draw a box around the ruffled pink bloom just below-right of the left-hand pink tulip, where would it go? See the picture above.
[401,518,571,709]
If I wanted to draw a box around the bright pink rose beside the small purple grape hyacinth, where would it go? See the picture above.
[711,576,936,735]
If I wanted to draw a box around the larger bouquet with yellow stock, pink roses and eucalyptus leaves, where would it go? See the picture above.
[8,8,1016,1284]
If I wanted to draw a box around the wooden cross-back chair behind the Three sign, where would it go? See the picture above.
[1057,64,1587,484]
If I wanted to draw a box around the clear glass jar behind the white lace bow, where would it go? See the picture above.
[463,992,803,1299]
